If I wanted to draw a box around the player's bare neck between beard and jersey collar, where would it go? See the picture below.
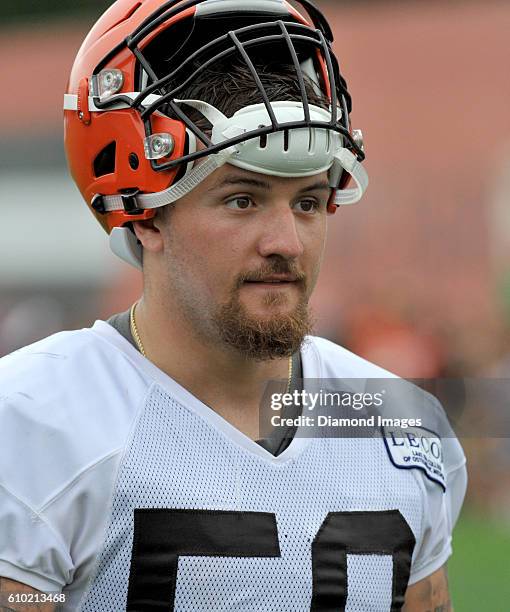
[131,299,289,438]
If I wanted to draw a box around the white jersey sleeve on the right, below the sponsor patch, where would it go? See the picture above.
[409,426,467,585]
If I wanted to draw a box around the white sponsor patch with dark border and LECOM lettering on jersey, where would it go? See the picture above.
[383,427,446,491]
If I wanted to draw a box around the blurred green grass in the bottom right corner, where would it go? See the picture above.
[448,513,510,612]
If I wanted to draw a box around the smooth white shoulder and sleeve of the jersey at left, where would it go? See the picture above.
[0,332,147,591]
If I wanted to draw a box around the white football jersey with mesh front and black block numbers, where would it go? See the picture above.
[0,321,466,612]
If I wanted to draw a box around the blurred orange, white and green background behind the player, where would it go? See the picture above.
[0,0,510,612]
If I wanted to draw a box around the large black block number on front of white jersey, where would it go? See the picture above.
[126,508,415,612]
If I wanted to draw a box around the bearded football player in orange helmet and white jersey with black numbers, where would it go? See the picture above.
[0,0,466,612]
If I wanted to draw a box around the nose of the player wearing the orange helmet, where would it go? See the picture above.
[258,204,303,259]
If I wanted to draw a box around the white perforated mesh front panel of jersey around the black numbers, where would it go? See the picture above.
[79,387,422,612]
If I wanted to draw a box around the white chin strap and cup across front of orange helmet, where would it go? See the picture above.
[103,100,368,269]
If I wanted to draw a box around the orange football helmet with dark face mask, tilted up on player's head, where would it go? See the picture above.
[64,0,367,263]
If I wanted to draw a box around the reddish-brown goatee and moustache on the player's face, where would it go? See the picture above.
[213,260,313,361]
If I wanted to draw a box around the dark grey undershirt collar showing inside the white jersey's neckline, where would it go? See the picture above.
[106,310,303,455]
